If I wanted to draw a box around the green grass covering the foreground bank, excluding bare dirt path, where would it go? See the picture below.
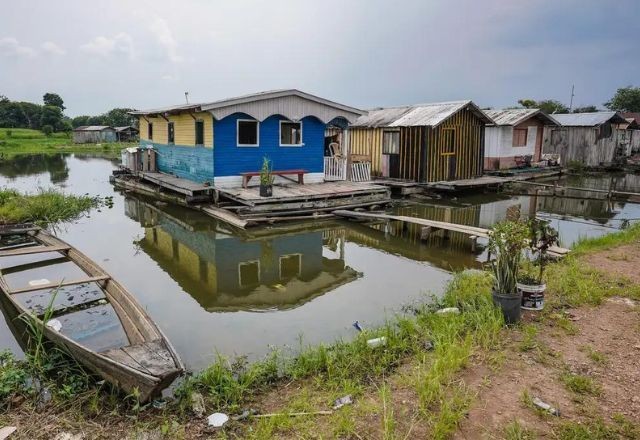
[0,225,640,440]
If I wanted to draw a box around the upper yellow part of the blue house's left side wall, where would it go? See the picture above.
[139,112,213,148]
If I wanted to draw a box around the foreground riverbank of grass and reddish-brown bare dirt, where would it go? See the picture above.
[0,226,640,439]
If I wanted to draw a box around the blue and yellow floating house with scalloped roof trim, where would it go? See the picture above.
[131,90,364,188]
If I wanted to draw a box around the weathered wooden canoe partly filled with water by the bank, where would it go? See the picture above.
[0,225,184,402]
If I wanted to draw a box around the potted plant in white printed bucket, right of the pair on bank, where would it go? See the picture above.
[517,219,558,310]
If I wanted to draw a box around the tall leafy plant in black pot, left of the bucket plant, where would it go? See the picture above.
[489,220,529,324]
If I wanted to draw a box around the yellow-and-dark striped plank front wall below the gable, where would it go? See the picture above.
[420,109,484,182]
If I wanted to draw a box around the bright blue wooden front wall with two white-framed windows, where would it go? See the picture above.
[213,113,325,177]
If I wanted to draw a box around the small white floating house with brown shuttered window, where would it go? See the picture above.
[484,109,559,170]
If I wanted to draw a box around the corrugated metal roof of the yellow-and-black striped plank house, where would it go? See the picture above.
[353,100,493,127]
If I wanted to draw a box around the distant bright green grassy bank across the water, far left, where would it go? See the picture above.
[0,128,129,157]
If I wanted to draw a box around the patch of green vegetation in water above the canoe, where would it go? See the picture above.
[0,189,102,225]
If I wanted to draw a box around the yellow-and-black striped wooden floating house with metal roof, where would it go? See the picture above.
[349,101,493,182]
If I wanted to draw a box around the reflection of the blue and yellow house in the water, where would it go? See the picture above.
[125,198,361,311]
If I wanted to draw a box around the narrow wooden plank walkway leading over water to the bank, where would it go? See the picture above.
[333,210,570,257]
